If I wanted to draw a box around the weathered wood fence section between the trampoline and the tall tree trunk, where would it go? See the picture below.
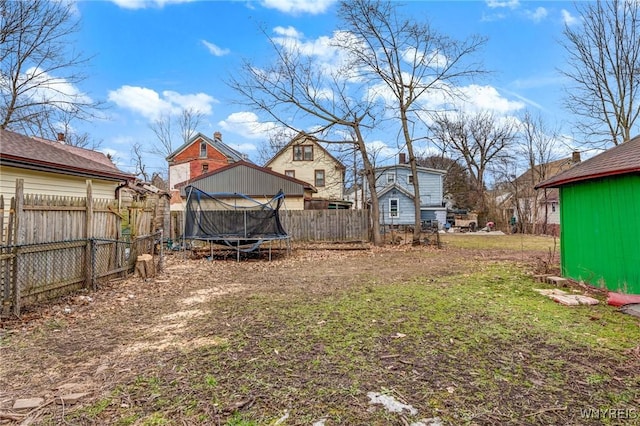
[280,209,369,241]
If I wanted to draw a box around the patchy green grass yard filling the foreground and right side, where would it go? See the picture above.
[0,235,640,426]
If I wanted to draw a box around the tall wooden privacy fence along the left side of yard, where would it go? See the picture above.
[0,179,162,316]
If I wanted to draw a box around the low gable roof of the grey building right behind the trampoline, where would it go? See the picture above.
[175,160,318,196]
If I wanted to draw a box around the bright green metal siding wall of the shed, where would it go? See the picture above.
[560,175,640,294]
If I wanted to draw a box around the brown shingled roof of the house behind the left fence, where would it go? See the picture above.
[0,129,134,181]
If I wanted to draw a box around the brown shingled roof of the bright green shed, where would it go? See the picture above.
[536,136,640,189]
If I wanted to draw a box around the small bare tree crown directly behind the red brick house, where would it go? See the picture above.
[149,108,204,158]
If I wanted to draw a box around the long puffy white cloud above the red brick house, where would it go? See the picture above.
[108,86,216,120]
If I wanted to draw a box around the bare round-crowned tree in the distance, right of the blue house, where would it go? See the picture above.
[431,112,517,220]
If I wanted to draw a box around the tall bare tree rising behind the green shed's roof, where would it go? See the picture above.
[562,0,640,145]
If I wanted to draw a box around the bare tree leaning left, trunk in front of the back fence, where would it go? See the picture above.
[228,28,382,245]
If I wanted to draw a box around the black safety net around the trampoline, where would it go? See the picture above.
[184,185,289,251]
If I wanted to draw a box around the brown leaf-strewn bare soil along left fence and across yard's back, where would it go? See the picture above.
[0,241,640,424]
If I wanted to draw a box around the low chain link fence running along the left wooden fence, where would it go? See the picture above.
[0,231,164,316]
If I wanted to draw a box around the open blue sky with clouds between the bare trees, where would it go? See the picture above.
[67,0,578,176]
